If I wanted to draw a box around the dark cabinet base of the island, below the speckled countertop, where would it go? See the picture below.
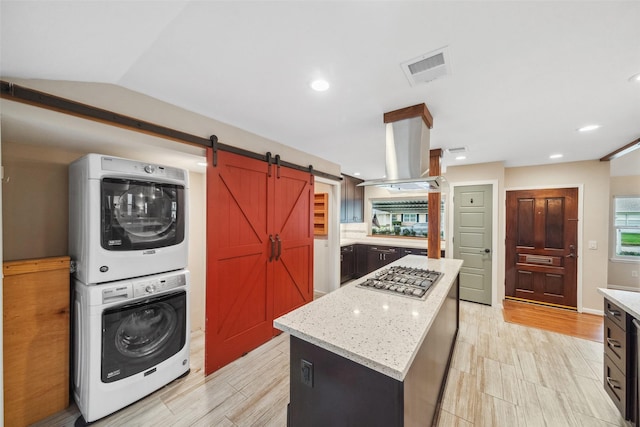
[287,279,459,427]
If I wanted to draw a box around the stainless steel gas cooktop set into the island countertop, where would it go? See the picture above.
[356,266,442,299]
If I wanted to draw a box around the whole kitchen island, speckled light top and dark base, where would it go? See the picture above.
[274,255,462,427]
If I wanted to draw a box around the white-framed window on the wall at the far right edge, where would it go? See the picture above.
[613,196,640,261]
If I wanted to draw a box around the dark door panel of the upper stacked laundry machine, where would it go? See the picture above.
[101,178,185,251]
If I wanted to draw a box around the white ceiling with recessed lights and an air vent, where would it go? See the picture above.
[0,0,640,179]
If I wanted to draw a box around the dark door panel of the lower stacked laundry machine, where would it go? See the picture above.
[101,290,187,383]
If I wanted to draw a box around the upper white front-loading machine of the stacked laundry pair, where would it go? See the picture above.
[69,154,189,285]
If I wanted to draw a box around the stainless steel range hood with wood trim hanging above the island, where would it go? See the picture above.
[358,104,448,193]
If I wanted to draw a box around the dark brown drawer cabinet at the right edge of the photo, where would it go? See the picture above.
[603,299,639,425]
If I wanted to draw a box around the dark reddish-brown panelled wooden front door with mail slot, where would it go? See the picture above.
[505,188,578,308]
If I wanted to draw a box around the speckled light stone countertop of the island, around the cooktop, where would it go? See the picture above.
[273,255,462,381]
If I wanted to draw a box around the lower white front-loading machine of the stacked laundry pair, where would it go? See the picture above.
[73,270,190,424]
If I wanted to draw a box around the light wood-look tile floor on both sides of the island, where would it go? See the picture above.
[36,302,628,427]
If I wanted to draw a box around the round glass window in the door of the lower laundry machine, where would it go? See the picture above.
[115,302,178,359]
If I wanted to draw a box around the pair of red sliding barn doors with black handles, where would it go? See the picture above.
[205,151,313,374]
